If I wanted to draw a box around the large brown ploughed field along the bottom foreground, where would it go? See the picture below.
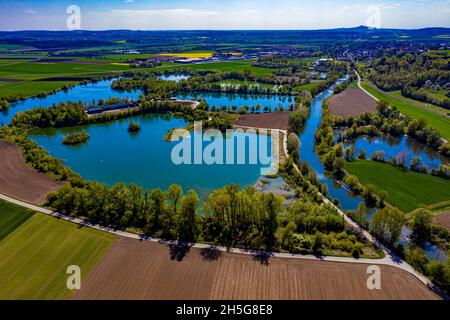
[74,238,438,300]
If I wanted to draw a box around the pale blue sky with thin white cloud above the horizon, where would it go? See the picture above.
[0,0,450,31]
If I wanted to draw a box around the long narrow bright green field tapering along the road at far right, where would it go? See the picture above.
[362,83,450,140]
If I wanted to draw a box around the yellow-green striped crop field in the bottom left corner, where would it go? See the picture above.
[0,200,115,299]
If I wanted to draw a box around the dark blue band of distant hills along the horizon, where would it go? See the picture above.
[0,26,450,51]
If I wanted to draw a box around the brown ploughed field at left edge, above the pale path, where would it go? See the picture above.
[0,140,62,204]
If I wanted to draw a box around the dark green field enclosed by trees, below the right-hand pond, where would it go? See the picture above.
[345,160,450,212]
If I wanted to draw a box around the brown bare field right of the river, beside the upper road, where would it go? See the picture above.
[330,88,377,117]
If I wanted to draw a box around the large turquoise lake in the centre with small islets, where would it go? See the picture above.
[30,114,270,198]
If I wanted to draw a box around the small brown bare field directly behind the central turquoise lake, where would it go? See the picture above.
[234,111,291,130]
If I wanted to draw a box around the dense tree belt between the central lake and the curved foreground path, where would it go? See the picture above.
[44,182,380,257]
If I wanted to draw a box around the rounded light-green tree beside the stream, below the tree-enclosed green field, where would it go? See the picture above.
[372,207,405,244]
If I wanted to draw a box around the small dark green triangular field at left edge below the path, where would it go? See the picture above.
[0,201,34,241]
